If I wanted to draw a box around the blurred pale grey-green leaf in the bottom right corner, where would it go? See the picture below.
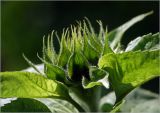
[121,88,159,112]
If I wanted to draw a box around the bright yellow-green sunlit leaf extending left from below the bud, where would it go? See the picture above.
[0,72,68,98]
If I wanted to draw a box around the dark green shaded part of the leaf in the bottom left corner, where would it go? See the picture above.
[1,98,50,112]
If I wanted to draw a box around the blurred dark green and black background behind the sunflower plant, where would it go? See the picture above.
[1,1,159,92]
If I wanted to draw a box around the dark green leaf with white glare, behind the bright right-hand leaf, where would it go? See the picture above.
[125,33,160,51]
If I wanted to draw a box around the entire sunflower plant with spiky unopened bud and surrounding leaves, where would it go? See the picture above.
[0,12,160,113]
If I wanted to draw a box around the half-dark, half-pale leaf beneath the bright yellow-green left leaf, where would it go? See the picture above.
[1,98,78,113]
